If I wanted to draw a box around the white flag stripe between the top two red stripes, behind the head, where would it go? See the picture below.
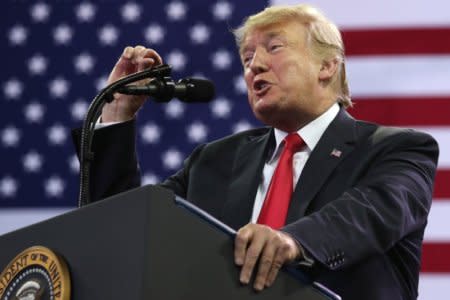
[347,55,450,97]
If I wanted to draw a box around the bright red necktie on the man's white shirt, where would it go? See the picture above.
[258,133,304,229]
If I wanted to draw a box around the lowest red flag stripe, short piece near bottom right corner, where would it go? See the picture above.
[421,242,450,273]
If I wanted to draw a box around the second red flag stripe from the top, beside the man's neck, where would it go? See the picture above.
[349,96,450,126]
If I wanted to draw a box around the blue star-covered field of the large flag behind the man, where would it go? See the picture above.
[0,0,267,208]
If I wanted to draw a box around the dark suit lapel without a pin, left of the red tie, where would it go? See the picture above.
[222,130,274,229]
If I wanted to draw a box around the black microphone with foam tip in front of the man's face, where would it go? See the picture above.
[117,77,215,102]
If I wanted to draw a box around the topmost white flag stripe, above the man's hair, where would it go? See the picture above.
[271,0,450,28]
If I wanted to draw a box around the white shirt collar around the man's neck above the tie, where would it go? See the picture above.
[270,103,339,160]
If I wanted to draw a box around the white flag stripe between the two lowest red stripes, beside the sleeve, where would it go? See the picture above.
[424,199,450,243]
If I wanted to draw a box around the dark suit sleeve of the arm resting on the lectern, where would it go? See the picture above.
[282,131,438,270]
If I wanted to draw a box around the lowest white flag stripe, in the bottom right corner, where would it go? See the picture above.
[417,273,450,300]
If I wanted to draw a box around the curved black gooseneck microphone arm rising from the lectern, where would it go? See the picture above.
[78,65,171,207]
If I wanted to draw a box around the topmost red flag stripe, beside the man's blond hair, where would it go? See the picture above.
[342,28,450,55]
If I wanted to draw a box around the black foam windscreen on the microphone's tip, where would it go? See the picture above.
[179,78,216,102]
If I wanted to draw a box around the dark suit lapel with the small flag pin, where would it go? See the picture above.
[286,108,355,223]
